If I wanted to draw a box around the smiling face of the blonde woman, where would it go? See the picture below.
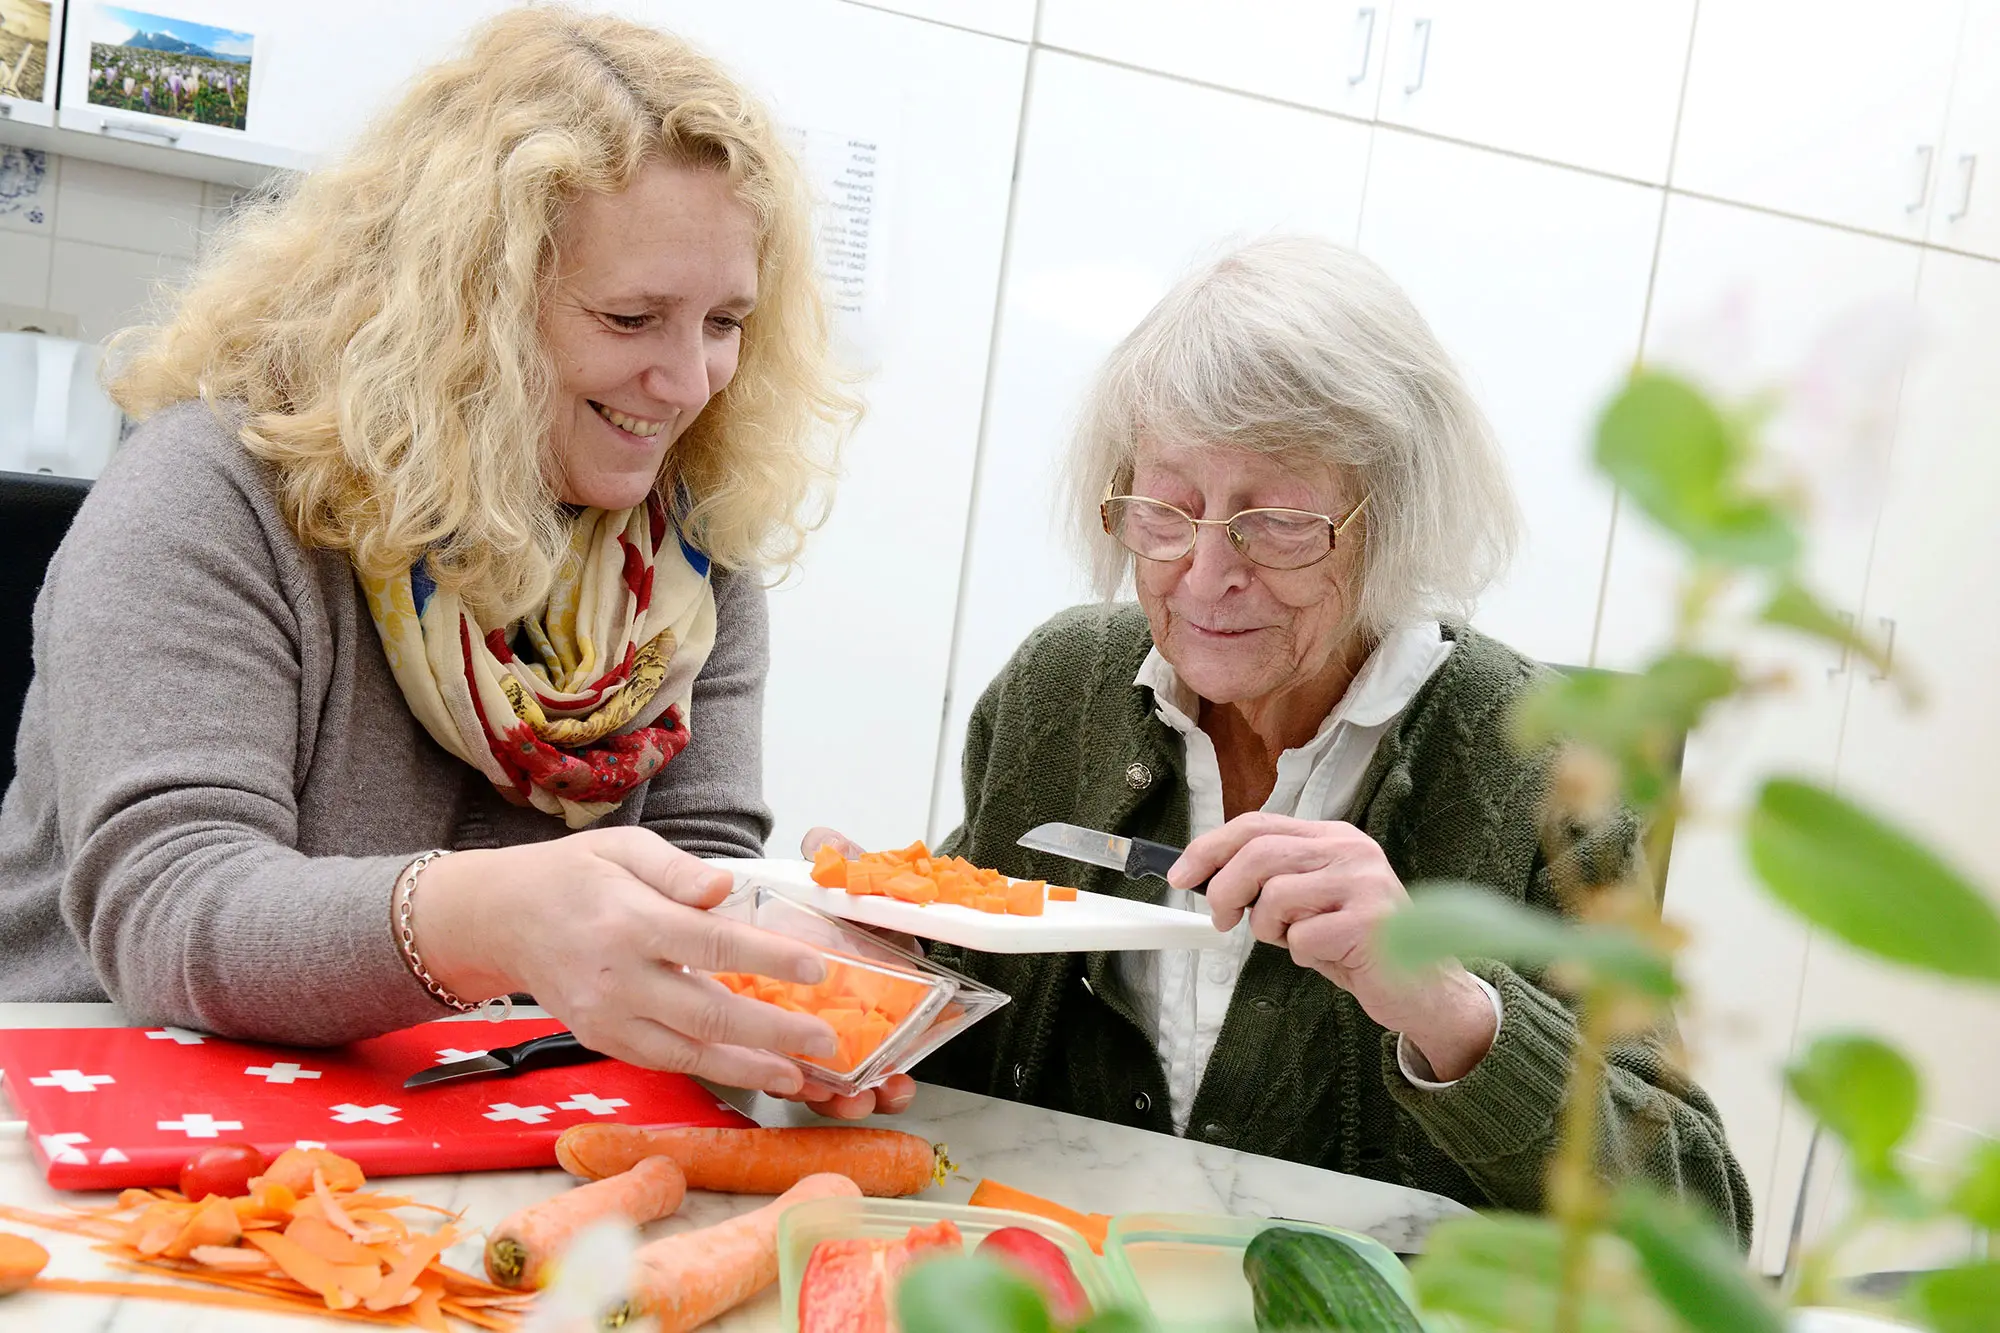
[542,162,758,508]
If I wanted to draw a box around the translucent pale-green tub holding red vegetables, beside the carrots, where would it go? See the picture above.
[778,1199,1144,1333]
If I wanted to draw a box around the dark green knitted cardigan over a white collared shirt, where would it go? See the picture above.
[916,604,1750,1247]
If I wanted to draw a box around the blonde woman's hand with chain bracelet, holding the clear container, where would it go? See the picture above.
[414,829,836,1095]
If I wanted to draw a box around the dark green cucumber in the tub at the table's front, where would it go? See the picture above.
[1244,1227,1424,1333]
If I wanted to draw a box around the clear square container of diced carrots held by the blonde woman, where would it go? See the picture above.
[716,885,1008,1097]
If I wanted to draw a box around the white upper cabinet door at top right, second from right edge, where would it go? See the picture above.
[1674,0,1964,238]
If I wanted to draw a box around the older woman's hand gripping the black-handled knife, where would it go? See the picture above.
[1168,813,1494,1081]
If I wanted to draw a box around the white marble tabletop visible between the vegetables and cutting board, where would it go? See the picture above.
[0,1005,1466,1333]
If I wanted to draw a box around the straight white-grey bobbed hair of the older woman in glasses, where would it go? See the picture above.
[1064,236,1520,634]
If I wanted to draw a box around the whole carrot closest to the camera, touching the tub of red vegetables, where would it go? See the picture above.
[604,1173,862,1333]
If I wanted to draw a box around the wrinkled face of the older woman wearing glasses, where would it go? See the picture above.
[1132,446,1360,705]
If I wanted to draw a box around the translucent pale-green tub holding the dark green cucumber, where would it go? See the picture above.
[1104,1213,1442,1333]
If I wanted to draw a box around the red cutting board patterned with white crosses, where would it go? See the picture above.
[0,1019,752,1189]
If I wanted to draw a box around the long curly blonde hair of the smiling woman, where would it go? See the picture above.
[110,8,860,620]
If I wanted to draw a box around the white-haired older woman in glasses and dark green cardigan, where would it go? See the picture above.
[844,240,1750,1241]
